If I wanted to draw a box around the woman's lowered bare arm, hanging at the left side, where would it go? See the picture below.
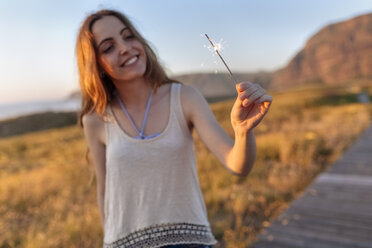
[83,113,106,230]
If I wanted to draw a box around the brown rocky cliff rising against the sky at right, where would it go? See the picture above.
[271,14,372,90]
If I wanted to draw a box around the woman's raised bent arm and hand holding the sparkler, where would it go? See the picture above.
[181,82,272,176]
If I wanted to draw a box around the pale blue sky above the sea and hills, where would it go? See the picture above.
[0,0,372,103]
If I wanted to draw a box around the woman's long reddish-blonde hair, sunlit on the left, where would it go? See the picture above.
[76,9,175,127]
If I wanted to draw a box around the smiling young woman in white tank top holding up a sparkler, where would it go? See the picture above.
[76,10,272,247]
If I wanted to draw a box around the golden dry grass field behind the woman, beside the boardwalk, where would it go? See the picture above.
[0,85,372,248]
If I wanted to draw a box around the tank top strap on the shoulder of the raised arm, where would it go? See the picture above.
[171,83,190,134]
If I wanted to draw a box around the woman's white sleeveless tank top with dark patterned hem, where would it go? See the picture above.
[103,83,217,248]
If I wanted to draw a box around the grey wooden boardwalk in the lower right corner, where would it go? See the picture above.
[252,126,372,248]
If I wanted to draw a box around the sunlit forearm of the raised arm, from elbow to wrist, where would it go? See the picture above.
[226,129,256,176]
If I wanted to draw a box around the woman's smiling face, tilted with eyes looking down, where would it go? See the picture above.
[92,16,146,81]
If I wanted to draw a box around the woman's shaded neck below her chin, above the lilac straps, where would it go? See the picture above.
[114,78,152,106]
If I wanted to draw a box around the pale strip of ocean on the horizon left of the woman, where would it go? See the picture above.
[0,98,81,120]
